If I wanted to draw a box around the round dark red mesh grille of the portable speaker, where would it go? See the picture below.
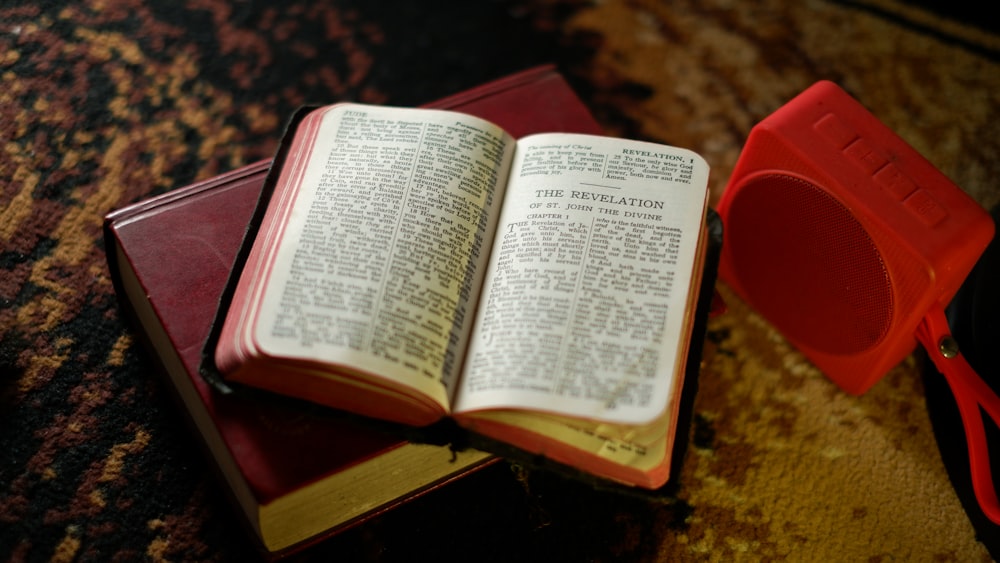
[726,173,893,354]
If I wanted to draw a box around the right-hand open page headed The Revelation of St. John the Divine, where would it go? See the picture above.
[456,135,708,424]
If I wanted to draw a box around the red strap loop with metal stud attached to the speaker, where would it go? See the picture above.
[917,308,1000,524]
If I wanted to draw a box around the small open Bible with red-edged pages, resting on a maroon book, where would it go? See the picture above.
[207,104,708,488]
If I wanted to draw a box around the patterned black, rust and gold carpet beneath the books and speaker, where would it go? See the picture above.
[0,0,1000,561]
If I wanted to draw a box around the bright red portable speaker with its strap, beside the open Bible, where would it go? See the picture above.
[718,82,1000,522]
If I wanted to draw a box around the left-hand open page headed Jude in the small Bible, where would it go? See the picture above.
[253,104,514,405]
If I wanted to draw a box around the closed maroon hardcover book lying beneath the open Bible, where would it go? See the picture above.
[105,66,601,555]
